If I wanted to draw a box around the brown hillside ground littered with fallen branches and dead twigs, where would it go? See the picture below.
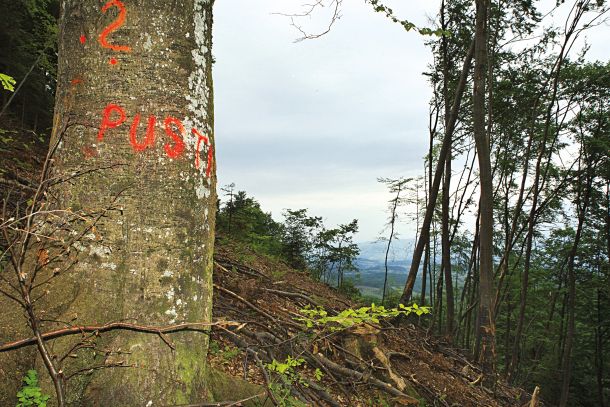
[209,238,542,407]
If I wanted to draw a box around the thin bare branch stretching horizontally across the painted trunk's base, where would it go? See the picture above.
[0,321,242,353]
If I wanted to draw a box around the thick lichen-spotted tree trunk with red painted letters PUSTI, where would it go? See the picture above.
[0,0,216,406]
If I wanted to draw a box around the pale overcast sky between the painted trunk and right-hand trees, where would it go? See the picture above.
[213,0,609,241]
